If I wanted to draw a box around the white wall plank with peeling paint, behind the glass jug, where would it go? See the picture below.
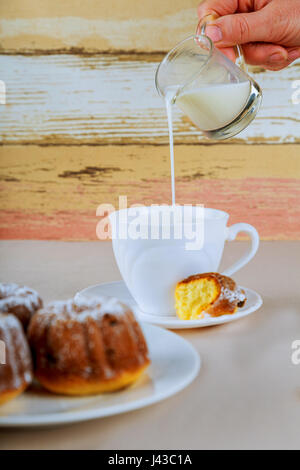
[0,55,300,144]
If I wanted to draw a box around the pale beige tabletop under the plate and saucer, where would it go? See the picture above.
[0,241,300,449]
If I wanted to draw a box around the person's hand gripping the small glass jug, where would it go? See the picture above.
[198,0,300,70]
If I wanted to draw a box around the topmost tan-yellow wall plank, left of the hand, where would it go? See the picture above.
[0,0,200,53]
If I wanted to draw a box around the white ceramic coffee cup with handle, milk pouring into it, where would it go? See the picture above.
[109,206,259,316]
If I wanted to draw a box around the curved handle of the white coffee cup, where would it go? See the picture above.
[222,223,259,276]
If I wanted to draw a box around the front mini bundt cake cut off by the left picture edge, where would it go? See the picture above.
[0,313,32,405]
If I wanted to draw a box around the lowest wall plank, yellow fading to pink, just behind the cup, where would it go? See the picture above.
[0,145,300,240]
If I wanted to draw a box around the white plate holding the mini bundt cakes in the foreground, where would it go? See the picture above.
[0,324,200,427]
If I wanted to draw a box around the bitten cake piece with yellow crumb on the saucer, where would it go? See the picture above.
[175,273,246,320]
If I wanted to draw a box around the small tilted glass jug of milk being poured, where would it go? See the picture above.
[155,18,262,140]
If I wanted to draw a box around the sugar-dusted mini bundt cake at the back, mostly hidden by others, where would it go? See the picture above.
[0,283,43,331]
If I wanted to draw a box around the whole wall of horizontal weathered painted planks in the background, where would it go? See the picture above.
[0,0,300,240]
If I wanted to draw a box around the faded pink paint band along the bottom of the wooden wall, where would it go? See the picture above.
[0,178,300,240]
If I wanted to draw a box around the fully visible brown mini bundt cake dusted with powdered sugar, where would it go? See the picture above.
[28,297,150,395]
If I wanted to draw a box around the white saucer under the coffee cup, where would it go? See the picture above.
[75,281,262,329]
